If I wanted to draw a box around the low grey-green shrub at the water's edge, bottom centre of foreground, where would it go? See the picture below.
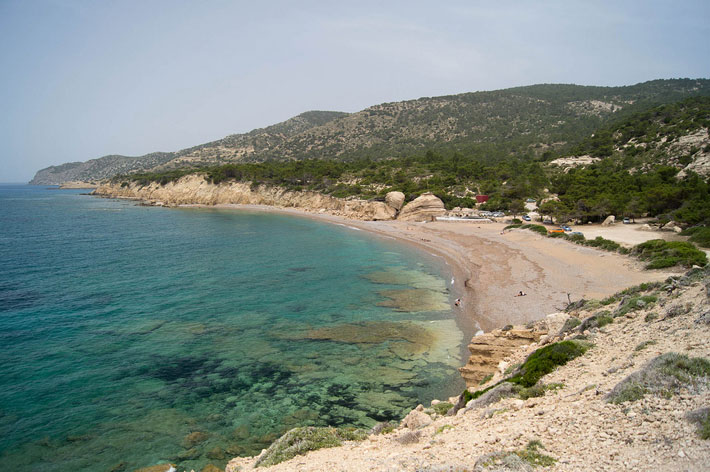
[255,426,367,467]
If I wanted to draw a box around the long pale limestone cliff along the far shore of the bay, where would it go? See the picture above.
[93,174,397,220]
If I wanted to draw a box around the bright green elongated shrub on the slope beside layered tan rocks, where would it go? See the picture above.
[508,341,589,387]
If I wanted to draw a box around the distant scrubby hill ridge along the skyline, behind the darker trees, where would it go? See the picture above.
[30,79,710,184]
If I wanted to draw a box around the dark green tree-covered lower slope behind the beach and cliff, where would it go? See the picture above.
[116,92,710,225]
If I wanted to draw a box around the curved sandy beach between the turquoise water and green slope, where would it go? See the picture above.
[202,204,673,333]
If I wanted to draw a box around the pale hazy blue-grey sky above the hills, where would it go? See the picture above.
[0,0,710,182]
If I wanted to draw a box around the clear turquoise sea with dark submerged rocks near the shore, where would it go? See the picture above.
[0,185,470,472]
